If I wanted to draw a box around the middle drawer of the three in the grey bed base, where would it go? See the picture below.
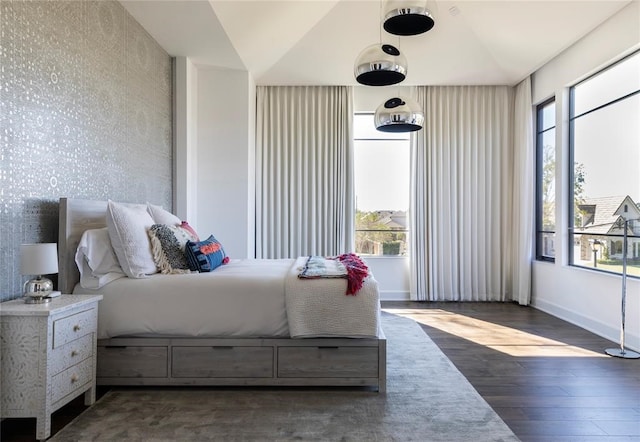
[171,346,273,378]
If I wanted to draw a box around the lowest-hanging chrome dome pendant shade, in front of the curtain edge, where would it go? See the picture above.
[374,97,424,132]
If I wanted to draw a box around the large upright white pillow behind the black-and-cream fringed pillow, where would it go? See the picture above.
[106,200,158,278]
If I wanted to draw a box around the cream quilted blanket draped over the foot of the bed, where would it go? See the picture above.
[285,256,380,338]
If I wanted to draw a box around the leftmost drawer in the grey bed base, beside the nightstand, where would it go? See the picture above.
[97,346,169,378]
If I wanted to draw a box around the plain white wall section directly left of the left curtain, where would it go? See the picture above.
[195,66,255,258]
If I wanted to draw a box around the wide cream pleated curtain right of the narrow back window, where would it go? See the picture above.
[410,83,533,303]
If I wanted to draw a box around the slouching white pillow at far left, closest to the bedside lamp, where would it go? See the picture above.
[75,227,127,289]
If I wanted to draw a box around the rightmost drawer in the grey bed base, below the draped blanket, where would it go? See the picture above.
[278,347,378,378]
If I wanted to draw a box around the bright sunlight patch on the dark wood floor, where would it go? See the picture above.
[383,308,607,358]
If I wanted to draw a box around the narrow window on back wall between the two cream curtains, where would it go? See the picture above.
[354,113,410,256]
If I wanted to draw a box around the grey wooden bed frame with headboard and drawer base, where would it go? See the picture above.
[58,198,386,392]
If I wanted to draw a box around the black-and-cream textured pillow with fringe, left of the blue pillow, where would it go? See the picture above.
[148,224,196,274]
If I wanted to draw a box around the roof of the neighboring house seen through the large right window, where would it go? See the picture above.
[576,195,640,235]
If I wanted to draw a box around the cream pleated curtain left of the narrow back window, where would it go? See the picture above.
[256,86,355,258]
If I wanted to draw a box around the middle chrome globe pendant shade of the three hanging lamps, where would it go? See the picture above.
[354,44,407,86]
